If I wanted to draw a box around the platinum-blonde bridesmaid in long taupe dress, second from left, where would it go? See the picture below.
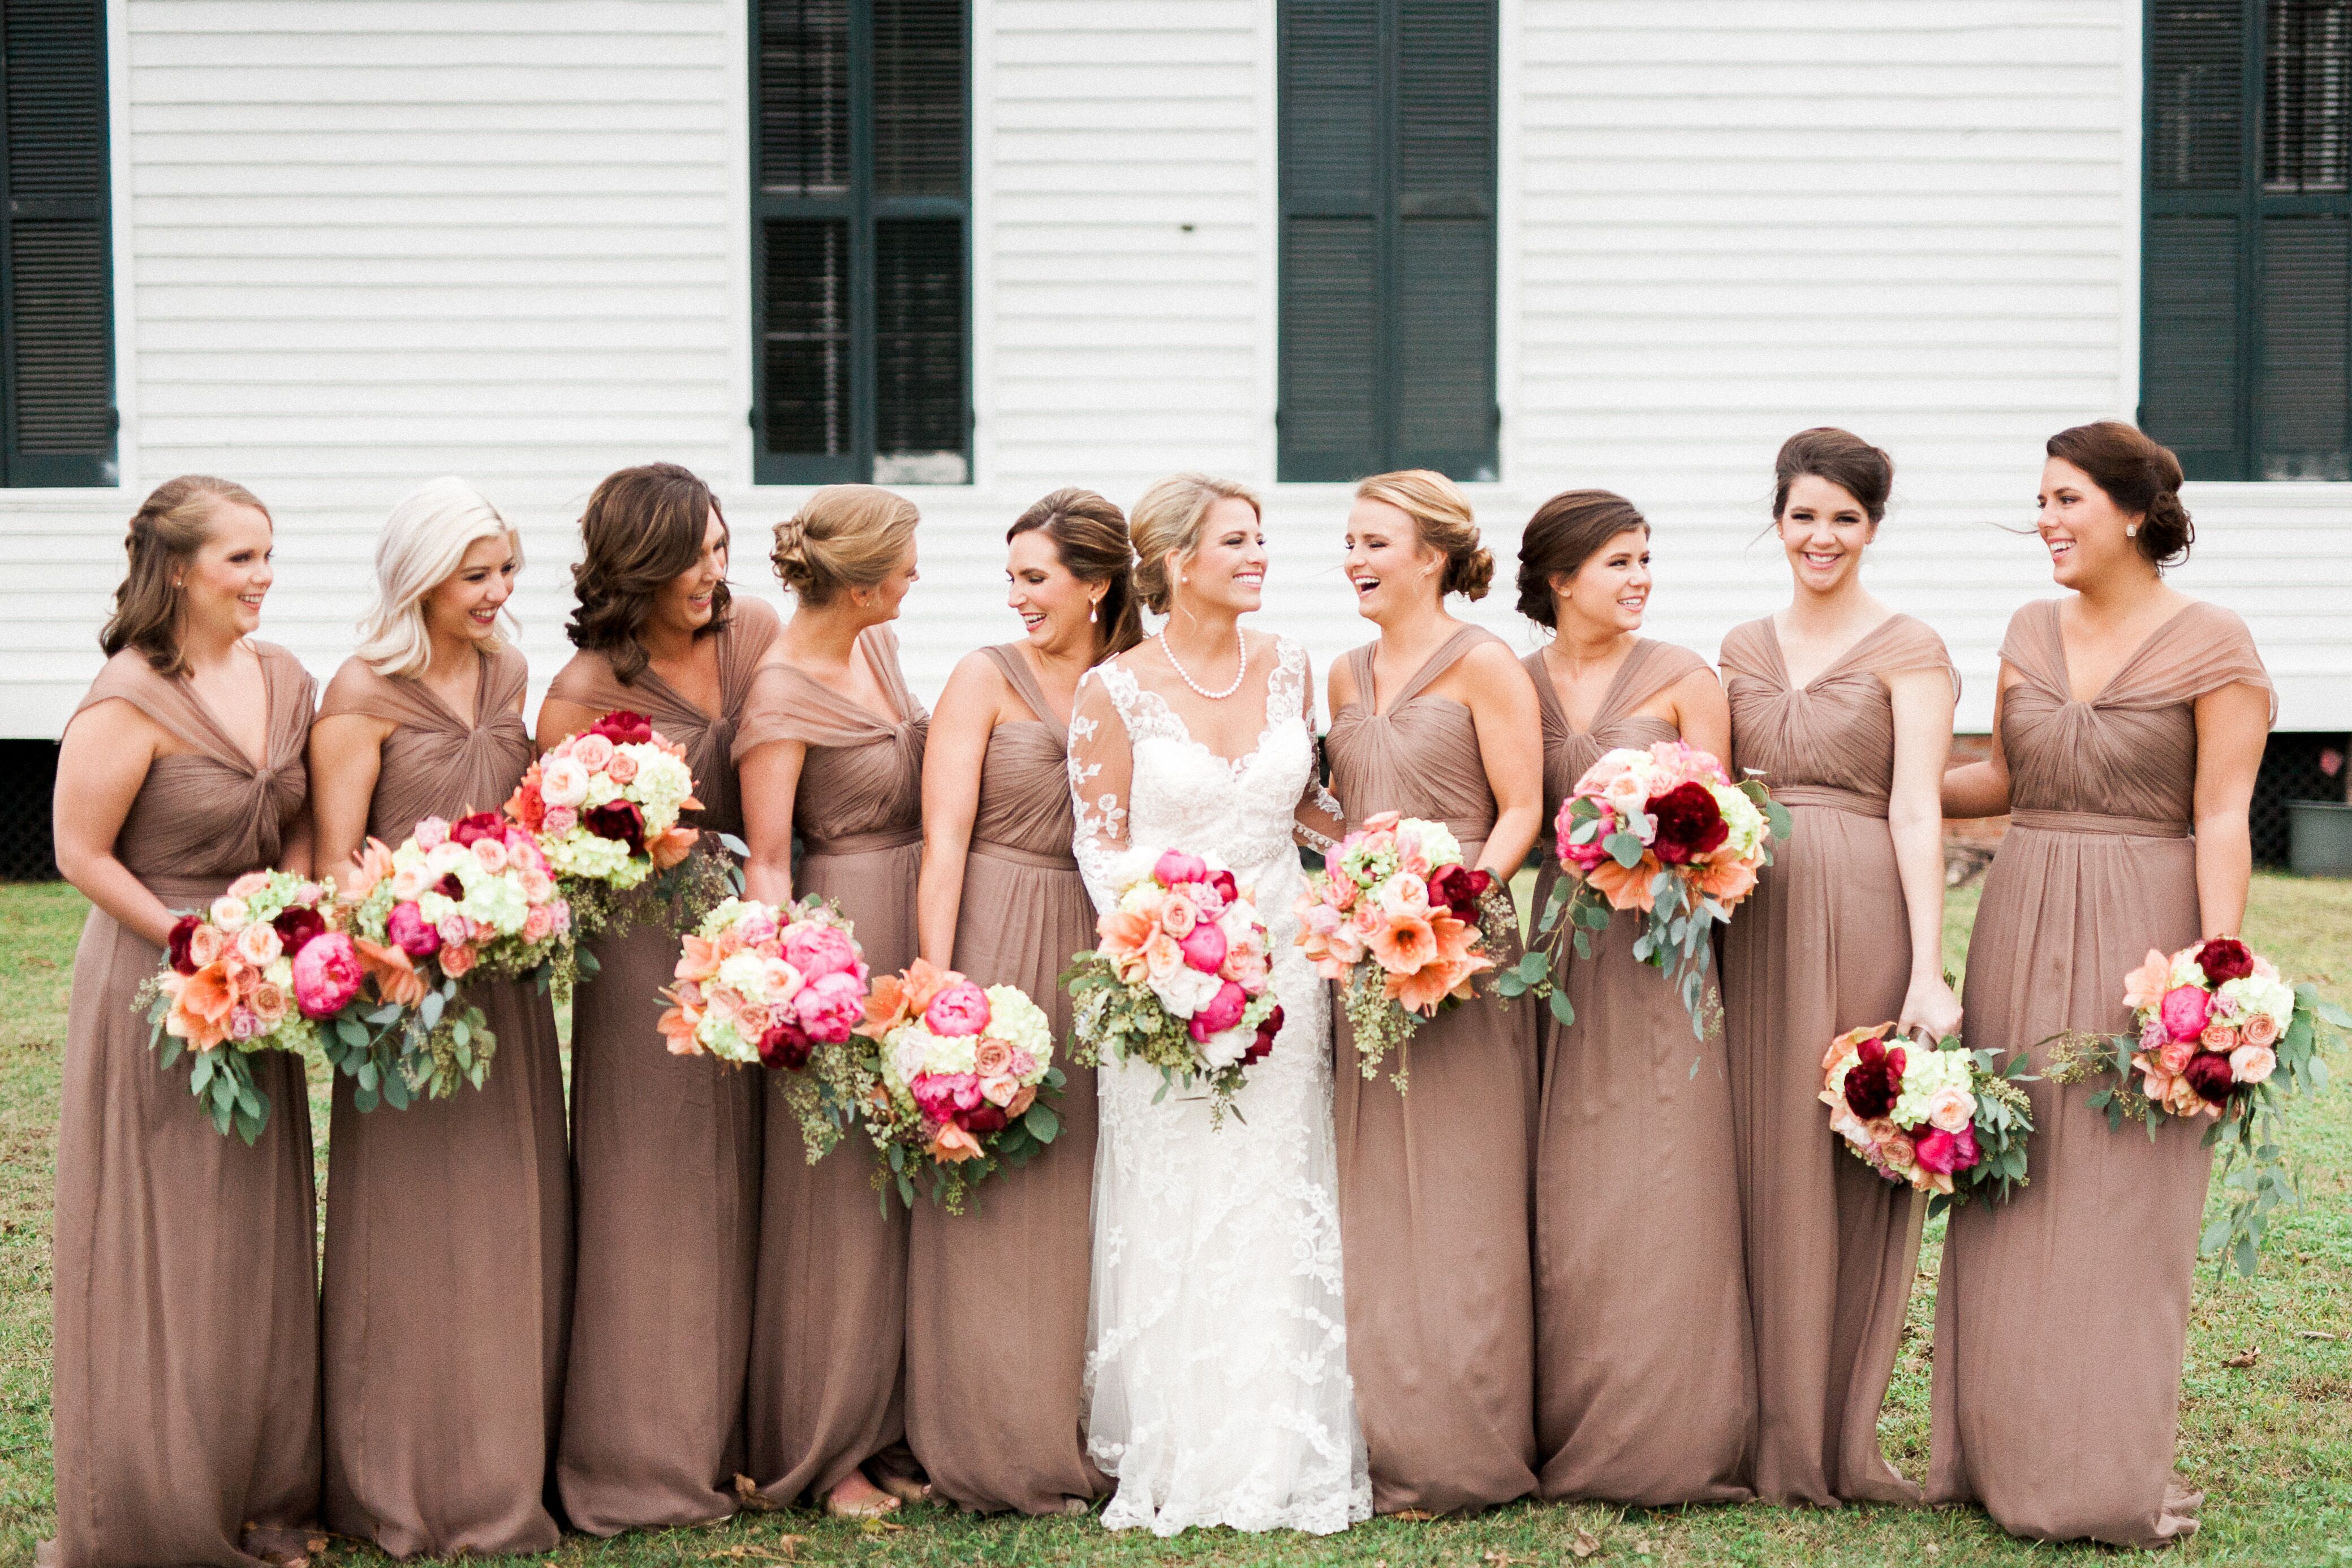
[311,477,571,1558]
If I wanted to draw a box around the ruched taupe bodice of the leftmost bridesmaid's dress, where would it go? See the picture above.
[75,642,317,901]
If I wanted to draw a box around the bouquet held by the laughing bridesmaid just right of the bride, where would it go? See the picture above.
[1298,811,1501,1091]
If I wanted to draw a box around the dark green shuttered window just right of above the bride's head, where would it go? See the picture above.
[1277,0,1501,480]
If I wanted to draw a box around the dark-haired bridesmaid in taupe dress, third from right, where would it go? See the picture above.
[1519,489,1755,1507]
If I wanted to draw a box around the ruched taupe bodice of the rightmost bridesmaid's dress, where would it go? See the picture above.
[2001,600,2269,832]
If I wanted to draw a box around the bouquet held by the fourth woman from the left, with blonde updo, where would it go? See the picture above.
[658,893,870,1164]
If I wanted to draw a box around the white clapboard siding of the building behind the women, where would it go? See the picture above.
[0,0,2352,736]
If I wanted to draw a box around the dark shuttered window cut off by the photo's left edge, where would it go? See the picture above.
[0,0,118,486]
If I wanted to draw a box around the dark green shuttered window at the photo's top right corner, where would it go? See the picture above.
[2140,0,2352,480]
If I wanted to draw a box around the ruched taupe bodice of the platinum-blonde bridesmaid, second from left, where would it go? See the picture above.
[320,647,532,844]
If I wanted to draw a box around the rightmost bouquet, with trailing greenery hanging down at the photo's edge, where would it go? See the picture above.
[2039,936,2352,1277]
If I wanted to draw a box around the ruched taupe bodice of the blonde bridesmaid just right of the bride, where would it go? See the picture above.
[1324,625,1503,860]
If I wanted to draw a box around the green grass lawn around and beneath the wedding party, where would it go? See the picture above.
[0,877,2352,1568]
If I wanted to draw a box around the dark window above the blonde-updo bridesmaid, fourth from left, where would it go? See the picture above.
[750,0,971,484]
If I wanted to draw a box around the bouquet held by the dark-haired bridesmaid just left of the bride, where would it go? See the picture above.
[859,959,1063,1213]
